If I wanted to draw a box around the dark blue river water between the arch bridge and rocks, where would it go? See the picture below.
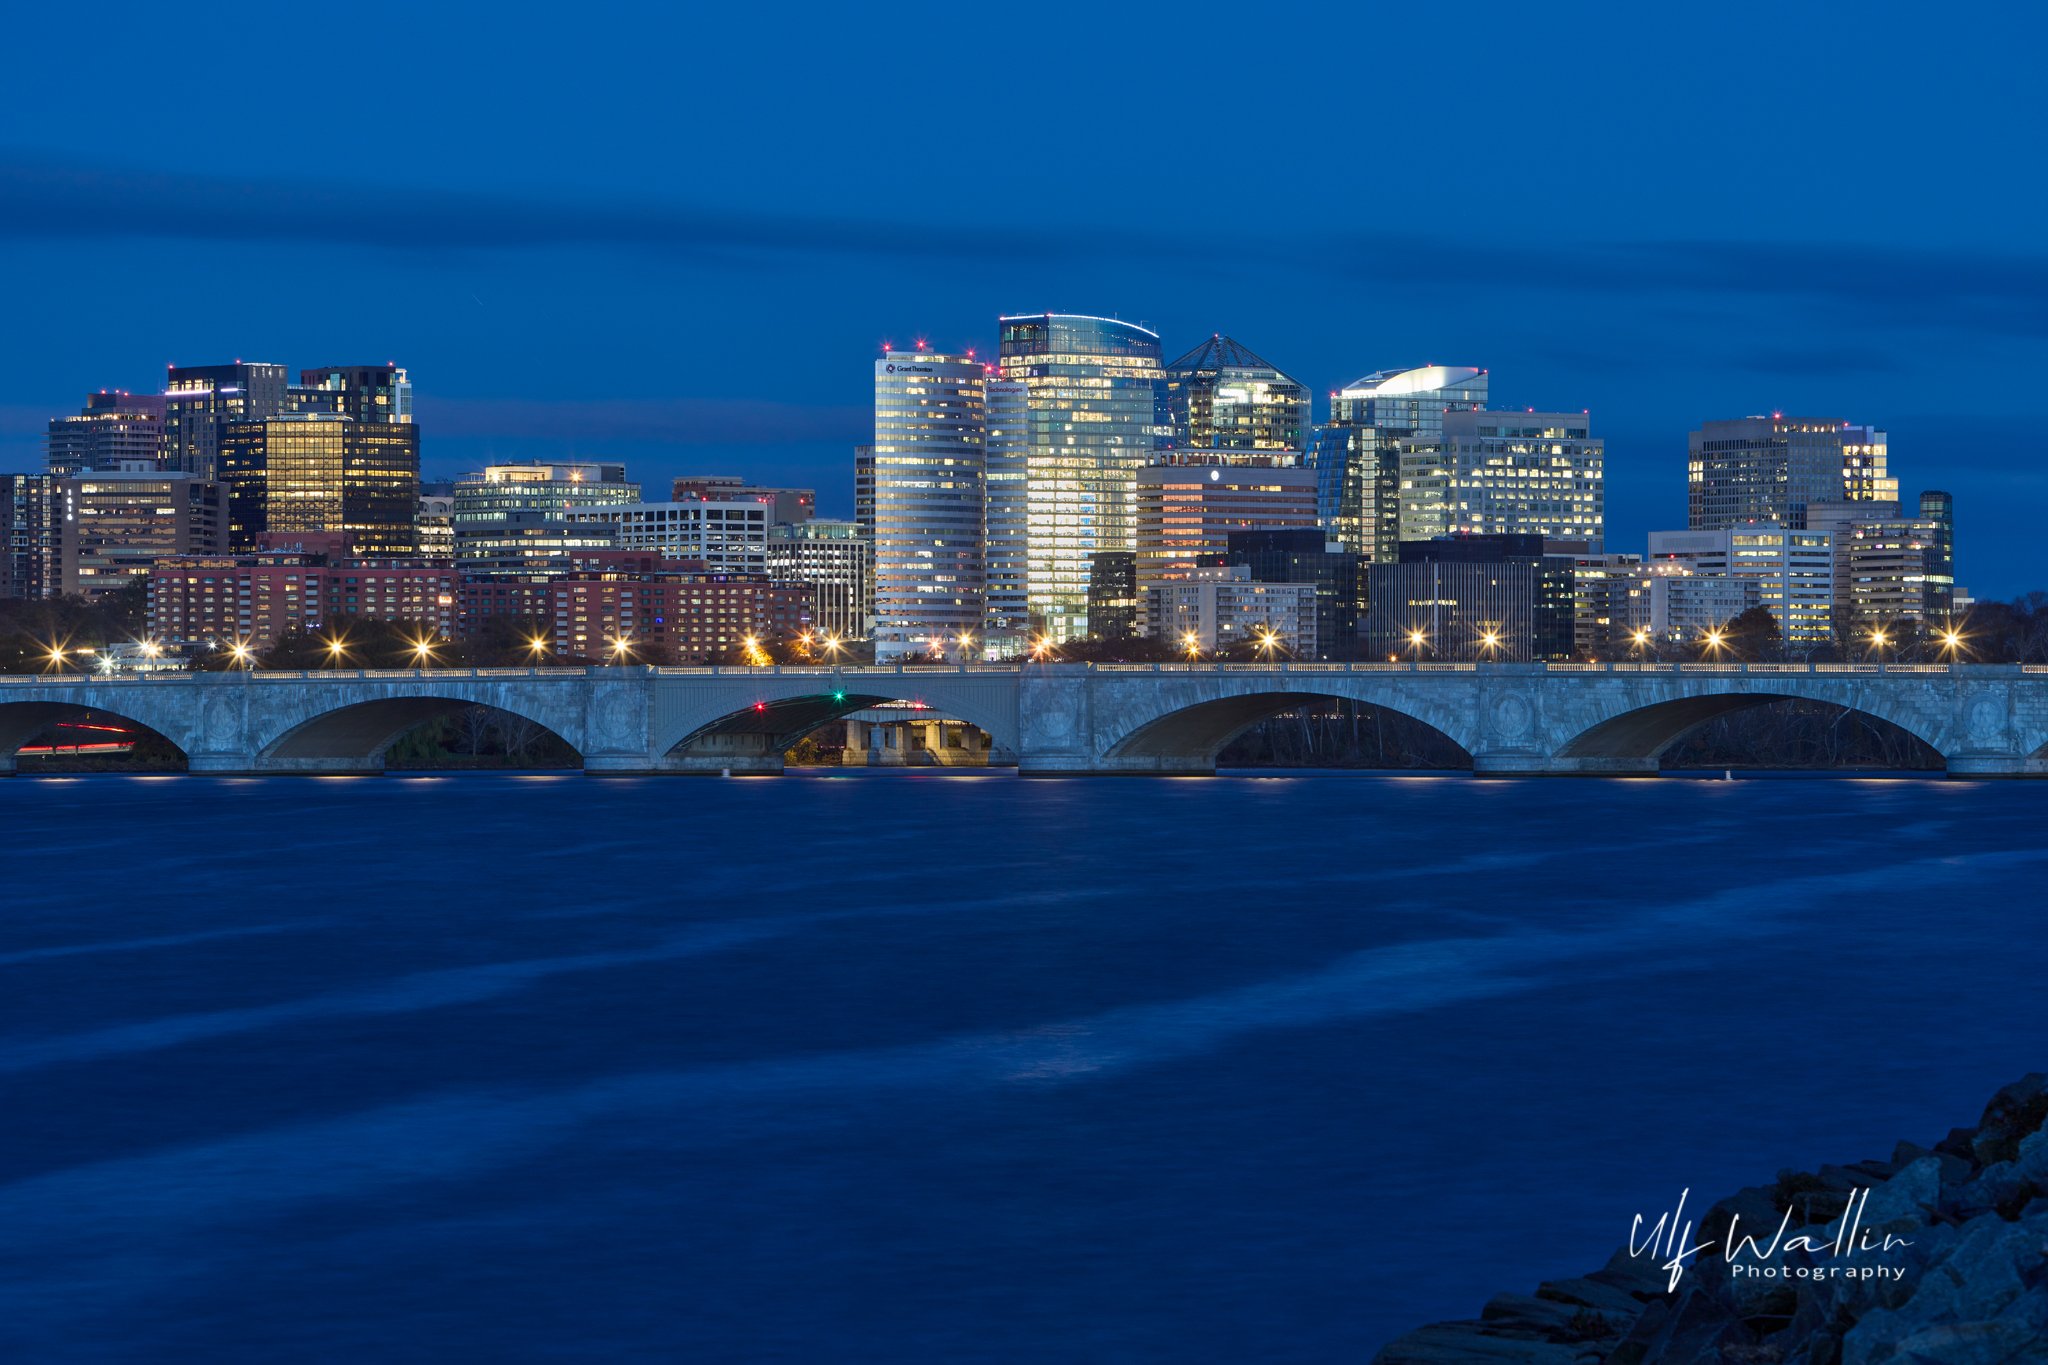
[0,774,2048,1363]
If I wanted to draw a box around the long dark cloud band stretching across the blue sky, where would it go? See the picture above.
[0,151,2048,338]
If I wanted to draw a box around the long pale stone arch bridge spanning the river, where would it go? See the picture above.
[0,663,2048,776]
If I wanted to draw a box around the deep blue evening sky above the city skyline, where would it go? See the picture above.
[0,2,2048,598]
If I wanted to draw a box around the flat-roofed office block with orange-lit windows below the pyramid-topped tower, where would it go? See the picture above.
[1137,452,1315,593]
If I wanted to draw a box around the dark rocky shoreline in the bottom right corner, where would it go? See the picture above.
[1374,1072,2048,1365]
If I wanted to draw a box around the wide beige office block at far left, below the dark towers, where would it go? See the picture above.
[57,469,227,598]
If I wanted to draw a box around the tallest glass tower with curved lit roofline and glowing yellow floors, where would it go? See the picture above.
[999,313,1165,643]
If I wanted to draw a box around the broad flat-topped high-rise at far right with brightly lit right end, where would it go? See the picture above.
[1686,413,1898,530]
